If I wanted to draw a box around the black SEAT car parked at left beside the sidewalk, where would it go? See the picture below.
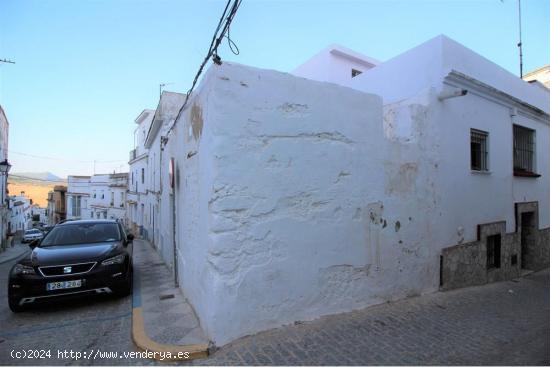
[8,220,134,312]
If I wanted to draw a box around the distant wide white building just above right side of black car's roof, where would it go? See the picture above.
[88,173,128,222]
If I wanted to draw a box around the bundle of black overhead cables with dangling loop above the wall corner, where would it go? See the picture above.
[164,0,242,143]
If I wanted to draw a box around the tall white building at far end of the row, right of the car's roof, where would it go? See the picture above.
[126,110,155,238]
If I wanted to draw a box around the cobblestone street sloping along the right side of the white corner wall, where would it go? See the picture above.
[197,270,550,365]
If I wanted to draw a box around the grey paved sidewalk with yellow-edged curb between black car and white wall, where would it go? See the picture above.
[132,239,208,360]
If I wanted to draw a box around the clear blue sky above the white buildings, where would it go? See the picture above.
[0,0,550,177]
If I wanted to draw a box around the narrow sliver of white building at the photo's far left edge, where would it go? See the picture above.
[0,106,11,251]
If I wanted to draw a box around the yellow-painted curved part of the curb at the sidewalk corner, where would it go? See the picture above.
[132,307,208,361]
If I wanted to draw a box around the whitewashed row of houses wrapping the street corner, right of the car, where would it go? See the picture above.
[127,36,550,345]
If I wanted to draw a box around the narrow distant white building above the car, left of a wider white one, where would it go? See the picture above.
[66,176,92,219]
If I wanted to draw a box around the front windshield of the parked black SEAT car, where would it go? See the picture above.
[40,223,121,247]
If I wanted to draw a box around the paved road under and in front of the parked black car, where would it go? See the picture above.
[0,243,151,365]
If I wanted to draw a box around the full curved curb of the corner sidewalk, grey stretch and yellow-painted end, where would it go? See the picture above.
[132,269,208,361]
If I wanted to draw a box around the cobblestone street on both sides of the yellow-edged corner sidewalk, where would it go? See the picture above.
[0,240,550,365]
